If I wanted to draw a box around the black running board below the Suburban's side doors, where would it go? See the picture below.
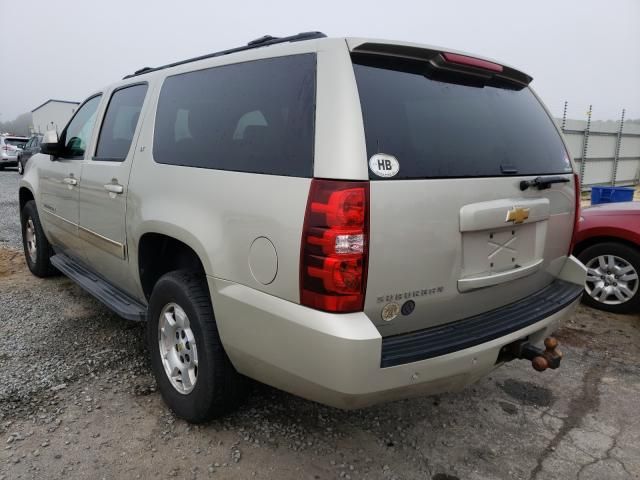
[51,253,147,322]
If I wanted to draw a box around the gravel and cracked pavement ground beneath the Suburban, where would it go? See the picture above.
[0,171,640,480]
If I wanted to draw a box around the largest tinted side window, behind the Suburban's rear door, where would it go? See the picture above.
[153,54,316,177]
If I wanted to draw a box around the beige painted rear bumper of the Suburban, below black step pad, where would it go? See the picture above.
[208,258,581,408]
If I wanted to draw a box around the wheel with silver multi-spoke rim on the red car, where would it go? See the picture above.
[578,242,640,313]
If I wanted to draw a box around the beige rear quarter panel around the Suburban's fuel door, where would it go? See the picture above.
[126,59,311,302]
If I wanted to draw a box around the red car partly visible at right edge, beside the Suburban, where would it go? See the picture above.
[573,202,640,313]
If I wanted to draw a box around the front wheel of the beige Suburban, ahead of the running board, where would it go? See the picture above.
[20,200,58,278]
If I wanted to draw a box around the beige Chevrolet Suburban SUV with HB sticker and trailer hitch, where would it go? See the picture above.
[19,32,585,422]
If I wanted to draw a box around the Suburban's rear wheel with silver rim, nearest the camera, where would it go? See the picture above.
[147,270,246,423]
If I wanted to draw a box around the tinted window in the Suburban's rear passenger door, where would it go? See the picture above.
[94,84,147,161]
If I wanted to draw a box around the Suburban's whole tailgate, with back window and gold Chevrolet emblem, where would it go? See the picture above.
[353,45,575,336]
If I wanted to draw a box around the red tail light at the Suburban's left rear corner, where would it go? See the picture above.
[300,179,369,313]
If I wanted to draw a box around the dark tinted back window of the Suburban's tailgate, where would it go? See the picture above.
[353,55,571,179]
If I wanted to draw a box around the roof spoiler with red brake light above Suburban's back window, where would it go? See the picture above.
[352,43,533,88]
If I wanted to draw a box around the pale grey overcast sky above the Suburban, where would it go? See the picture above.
[0,0,640,121]
